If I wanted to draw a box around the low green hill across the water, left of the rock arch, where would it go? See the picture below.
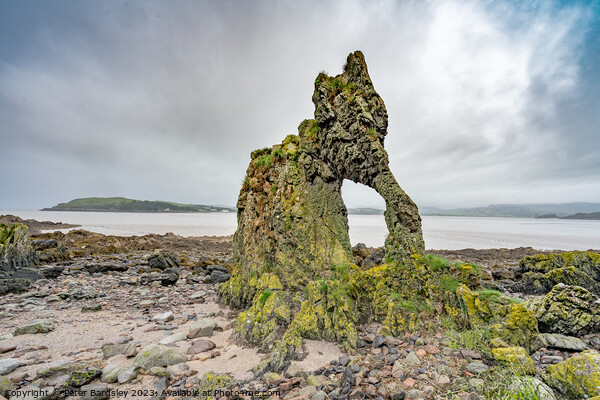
[42,197,235,212]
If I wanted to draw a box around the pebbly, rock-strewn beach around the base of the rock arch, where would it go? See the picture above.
[0,216,600,400]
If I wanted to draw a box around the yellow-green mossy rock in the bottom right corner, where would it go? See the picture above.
[543,350,600,400]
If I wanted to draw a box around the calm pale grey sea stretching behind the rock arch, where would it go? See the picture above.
[0,211,600,250]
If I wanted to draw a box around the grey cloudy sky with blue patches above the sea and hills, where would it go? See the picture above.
[0,0,600,209]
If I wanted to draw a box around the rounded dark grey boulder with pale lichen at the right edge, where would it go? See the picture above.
[525,283,600,336]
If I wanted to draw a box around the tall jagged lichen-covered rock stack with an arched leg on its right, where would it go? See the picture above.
[220,51,424,372]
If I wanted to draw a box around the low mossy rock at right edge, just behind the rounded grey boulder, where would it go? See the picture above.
[517,251,600,294]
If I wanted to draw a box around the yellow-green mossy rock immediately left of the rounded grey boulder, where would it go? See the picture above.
[490,304,543,353]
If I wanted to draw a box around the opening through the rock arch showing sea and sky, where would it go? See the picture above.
[342,179,389,247]
